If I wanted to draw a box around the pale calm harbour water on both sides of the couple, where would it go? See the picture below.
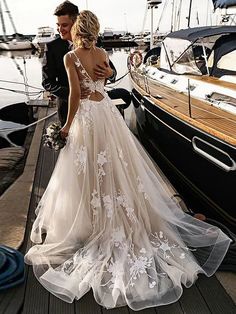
[0,48,133,109]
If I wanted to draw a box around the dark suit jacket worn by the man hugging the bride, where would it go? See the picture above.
[42,37,117,101]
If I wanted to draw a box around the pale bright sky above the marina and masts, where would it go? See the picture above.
[0,0,217,34]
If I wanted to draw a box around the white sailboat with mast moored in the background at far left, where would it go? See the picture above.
[0,0,33,51]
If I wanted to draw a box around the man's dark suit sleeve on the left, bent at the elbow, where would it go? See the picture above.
[42,45,69,99]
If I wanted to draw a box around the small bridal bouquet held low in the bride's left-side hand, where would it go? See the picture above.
[43,122,66,151]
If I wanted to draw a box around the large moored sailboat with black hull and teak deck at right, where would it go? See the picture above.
[128,25,236,228]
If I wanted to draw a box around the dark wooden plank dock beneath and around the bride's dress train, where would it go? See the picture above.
[0,109,236,314]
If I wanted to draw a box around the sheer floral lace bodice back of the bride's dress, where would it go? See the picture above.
[69,51,105,95]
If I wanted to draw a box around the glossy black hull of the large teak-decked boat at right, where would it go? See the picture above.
[132,88,236,227]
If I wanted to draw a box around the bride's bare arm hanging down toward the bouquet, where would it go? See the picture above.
[61,54,81,137]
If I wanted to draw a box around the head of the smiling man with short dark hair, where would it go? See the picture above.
[54,1,79,40]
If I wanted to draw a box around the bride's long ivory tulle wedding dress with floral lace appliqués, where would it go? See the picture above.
[25,52,231,310]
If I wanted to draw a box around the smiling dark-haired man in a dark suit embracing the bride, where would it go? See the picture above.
[42,1,131,126]
